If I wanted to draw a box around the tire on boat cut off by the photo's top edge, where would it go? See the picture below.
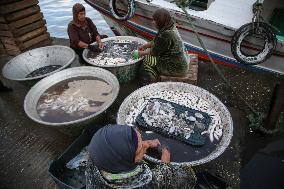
[109,0,135,21]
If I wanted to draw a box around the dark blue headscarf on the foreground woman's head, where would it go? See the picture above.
[88,125,137,173]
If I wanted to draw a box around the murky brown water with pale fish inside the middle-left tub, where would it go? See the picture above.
[37,76,113,123]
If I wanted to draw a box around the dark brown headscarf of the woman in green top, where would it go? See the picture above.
[153,8,174,32]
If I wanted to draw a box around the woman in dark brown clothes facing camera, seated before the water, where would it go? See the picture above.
[67,3,107,62]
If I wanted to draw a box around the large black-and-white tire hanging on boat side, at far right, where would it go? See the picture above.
[231,22,277,65]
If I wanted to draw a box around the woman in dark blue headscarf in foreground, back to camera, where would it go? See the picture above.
[86,125,196,189]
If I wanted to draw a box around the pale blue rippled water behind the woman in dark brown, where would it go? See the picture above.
[39,0,114,39]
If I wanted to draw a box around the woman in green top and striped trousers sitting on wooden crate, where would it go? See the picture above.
[138,8,188,82]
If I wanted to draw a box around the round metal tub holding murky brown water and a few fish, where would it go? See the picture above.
[24,66,119,136]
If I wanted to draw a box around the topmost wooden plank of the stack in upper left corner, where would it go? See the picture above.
[0,0,38,14]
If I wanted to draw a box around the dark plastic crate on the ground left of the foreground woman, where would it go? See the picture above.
[48,126,100,189]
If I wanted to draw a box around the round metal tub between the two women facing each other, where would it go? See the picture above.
[83,36,146,83]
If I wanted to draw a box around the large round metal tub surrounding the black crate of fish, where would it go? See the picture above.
[117,82,233,166]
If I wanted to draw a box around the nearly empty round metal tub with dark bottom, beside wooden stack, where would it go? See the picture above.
[2,45,75,85]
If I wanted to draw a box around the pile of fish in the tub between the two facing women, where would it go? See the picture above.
[88,40,140,66]
